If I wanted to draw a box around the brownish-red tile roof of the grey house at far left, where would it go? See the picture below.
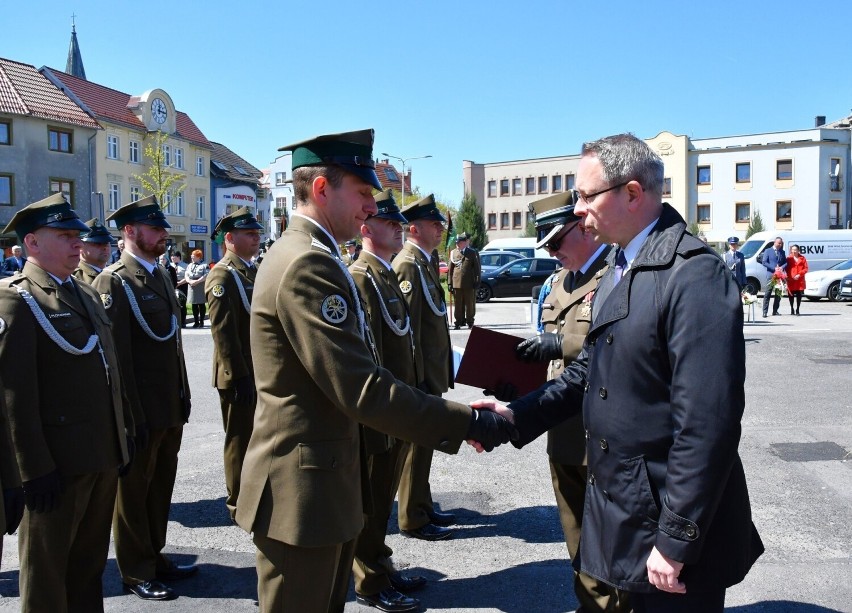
[0,58,100,129]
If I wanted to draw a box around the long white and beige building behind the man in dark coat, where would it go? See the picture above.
[463,126,852,247]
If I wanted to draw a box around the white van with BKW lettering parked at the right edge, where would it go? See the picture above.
[740,230,852,294]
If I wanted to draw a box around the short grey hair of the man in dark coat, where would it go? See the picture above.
[582,133,664,196]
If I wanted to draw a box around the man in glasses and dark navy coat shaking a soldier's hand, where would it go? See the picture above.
[472,134,763,613]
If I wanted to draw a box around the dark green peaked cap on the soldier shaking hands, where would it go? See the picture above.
[278,129,382,189]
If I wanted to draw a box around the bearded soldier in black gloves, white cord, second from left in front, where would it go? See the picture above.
[93,196,198,600]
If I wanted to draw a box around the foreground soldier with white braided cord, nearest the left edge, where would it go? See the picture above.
[0,194,133,612]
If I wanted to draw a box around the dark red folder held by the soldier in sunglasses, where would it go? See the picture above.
[456,326,548,396]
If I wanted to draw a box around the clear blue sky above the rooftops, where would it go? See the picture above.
[0,0,852,205]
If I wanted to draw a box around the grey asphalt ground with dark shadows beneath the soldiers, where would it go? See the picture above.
[0,299,852,613]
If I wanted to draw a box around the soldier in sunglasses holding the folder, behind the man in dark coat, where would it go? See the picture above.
[518,191,631,613]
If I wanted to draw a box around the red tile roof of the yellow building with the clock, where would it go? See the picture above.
[43,68,212,149]
